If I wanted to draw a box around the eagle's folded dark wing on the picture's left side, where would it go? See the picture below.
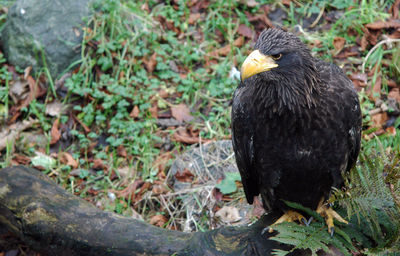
[232,83,259,204]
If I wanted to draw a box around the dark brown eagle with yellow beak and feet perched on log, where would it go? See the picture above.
[231,28,362,235]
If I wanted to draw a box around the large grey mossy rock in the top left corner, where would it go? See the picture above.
[0,0,91,77]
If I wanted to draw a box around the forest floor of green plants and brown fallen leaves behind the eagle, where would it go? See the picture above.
[0,0,400,255]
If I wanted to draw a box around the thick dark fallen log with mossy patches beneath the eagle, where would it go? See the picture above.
[0,166,306,255]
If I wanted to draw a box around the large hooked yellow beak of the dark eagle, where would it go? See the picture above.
[240,50,278,81]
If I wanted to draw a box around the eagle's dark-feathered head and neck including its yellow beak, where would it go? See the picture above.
[241,29,321,111]
